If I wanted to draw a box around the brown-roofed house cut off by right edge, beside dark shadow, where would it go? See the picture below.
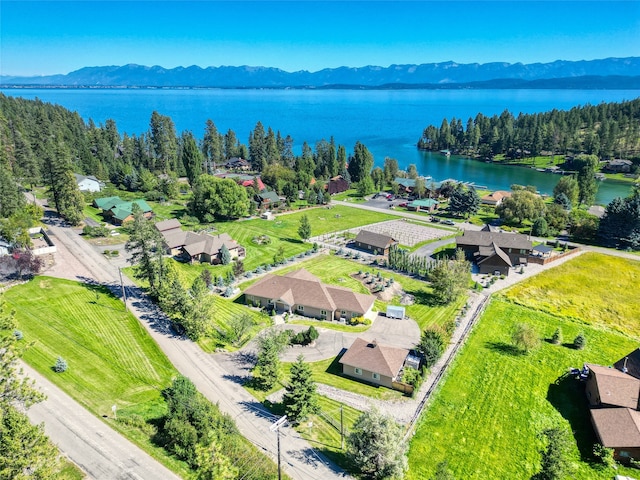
[583,350,640,461]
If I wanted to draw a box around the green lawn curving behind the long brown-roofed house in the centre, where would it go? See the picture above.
[240,254,466,329]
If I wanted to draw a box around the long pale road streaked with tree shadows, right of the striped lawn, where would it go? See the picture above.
[40,216,347,480]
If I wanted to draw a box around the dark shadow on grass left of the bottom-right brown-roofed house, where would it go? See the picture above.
[547,374,599,465]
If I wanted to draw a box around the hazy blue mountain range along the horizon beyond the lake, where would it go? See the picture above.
[0,57,640,89]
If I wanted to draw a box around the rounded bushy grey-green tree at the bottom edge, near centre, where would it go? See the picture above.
[347,407,407,479]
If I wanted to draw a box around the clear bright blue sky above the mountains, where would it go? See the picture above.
[0,0,640,75]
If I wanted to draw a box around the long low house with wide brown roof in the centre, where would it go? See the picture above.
[244,269,375,320]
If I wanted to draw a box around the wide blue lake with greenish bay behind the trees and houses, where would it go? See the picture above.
[0,89,640,204]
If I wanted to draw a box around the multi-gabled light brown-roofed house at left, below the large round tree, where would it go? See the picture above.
[155,219,246,264]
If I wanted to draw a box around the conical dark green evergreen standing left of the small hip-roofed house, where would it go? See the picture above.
[282,354,320,424]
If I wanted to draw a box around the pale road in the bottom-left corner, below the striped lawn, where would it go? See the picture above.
[23,364,180,480]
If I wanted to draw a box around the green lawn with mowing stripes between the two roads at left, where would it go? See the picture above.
[4,277,191,478]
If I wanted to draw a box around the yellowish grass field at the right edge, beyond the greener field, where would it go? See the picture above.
[504,252,640,337]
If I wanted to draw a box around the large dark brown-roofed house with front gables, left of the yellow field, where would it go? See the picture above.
[456,230,533,275]
